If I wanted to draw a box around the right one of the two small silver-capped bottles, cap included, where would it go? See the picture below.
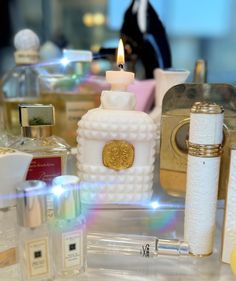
[52,175,87,278]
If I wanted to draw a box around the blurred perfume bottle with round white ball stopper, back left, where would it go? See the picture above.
[1,29,39,135]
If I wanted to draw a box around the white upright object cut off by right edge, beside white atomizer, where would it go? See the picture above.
[222,149,236,263]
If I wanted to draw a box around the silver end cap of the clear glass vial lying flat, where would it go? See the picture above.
[156,239,189,256]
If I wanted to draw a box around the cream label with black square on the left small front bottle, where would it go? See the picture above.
[26,237,49,277]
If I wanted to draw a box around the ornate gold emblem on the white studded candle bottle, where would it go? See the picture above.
[102,140,134,171]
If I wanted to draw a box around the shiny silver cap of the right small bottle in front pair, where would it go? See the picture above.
[52,175,81,220]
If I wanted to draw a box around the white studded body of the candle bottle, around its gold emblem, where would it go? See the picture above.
[77,92,156,204]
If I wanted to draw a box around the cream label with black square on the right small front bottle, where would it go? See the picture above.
[62,230,83,269]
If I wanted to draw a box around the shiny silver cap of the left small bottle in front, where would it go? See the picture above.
[16,180,47,228]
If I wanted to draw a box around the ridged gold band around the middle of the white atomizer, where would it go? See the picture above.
[187,141,223,158]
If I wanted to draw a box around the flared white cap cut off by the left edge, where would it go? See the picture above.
[0,147,33,208]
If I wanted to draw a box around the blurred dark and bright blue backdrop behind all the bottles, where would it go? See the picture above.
[0,0,236,83]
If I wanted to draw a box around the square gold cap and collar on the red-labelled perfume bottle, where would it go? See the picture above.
[19,104,55,138]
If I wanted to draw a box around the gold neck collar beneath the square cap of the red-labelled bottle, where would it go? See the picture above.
[21,126,52,139]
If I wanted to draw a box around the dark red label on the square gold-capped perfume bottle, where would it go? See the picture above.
[26,156,62,183]
